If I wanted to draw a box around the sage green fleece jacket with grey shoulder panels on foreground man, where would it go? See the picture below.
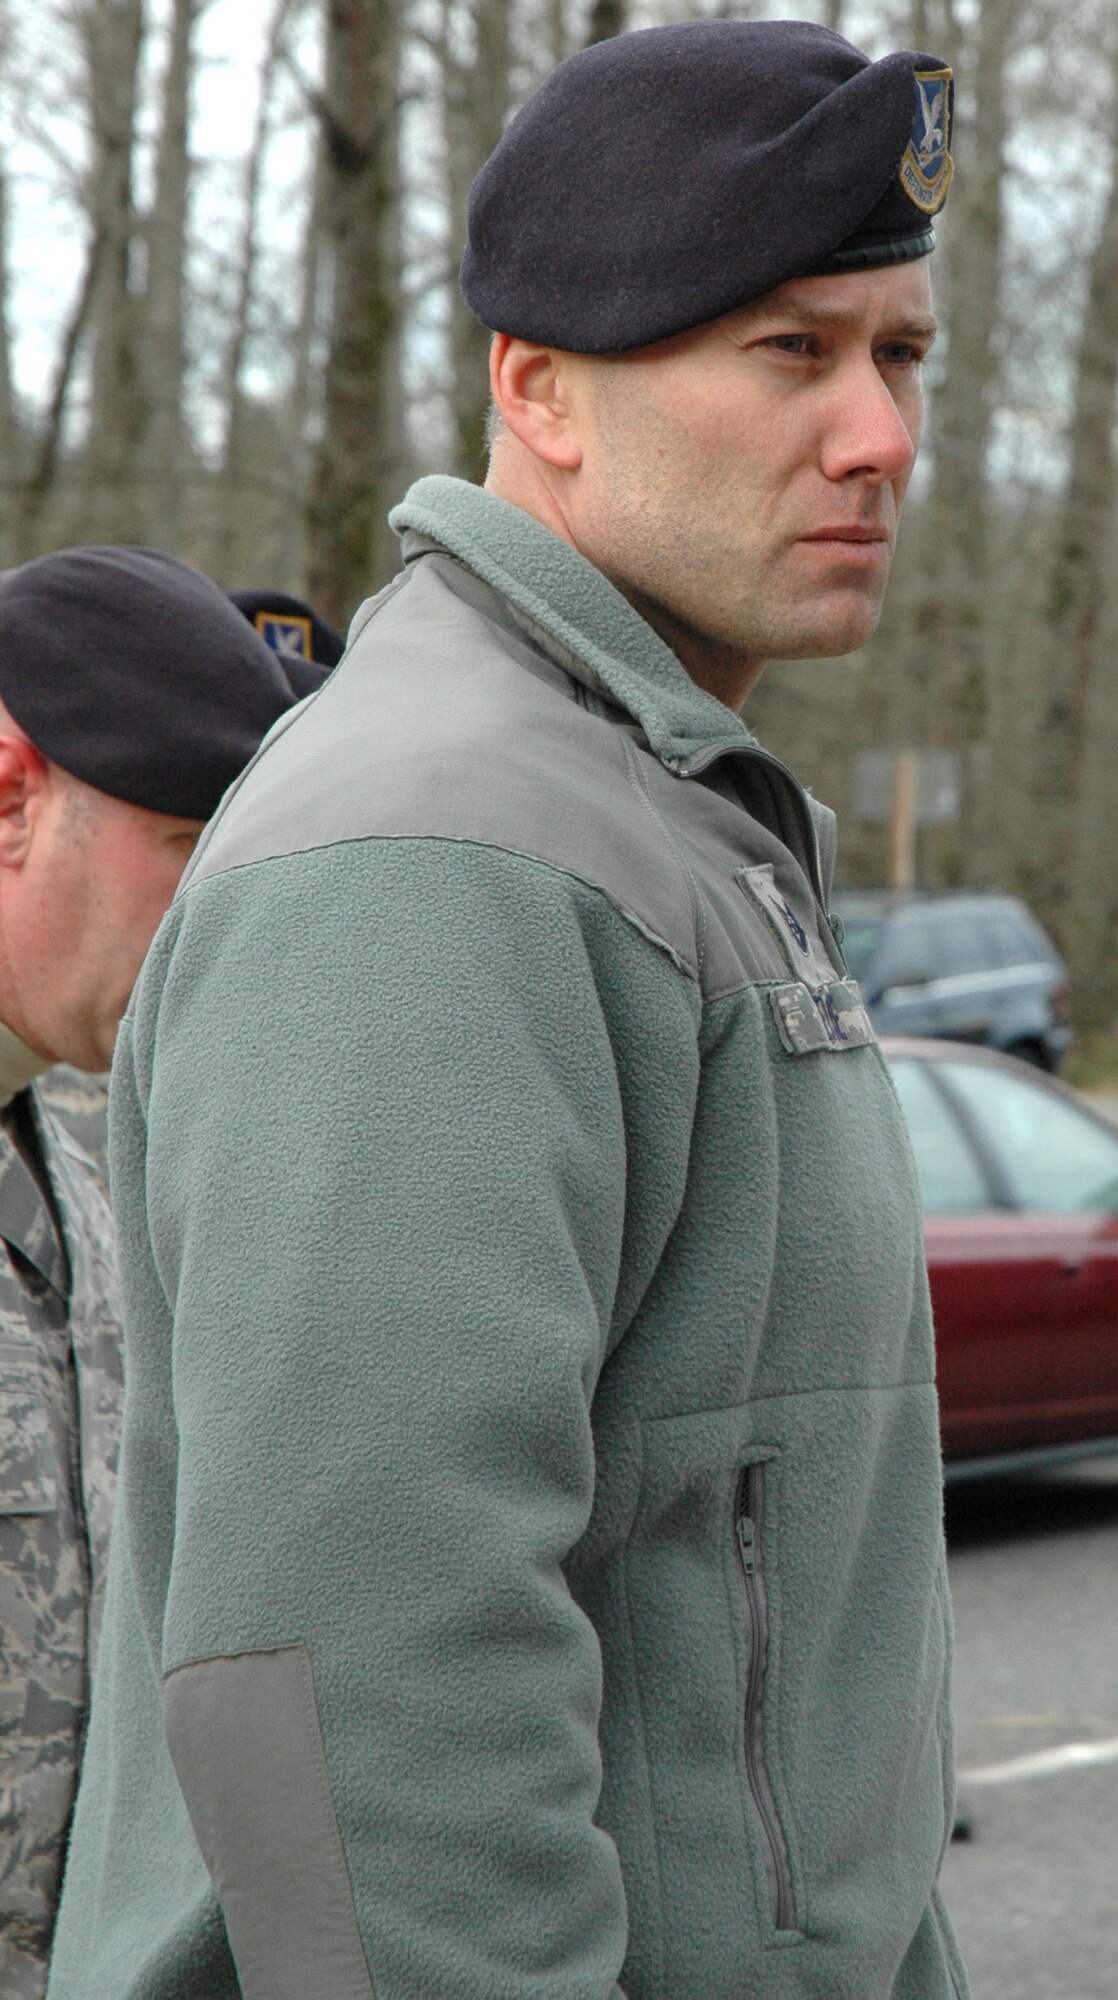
[50,478,966,2000]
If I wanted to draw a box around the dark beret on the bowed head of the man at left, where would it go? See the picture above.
[0,548,306,820]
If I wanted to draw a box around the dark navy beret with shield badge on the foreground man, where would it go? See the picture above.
[462,20,952,354]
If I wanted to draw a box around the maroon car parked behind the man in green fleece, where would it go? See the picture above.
[884,1038,1118,1472]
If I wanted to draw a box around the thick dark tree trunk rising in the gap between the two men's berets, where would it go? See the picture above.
[308,0,400,628]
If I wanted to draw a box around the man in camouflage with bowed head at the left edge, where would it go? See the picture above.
[0,548,322,2000]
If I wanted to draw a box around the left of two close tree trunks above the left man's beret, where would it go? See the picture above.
[80,0,146,542]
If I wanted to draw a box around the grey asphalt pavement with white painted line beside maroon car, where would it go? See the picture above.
[944,1460,1118,2000]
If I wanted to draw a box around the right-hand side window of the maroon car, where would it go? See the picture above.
[938,1062,1118,1214]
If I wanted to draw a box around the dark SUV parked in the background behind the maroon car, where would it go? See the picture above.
[834,890,1072,1070]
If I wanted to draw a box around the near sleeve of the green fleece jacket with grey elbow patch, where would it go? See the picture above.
[122,842,694,2000]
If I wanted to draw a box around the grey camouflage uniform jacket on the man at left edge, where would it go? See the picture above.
[0,1088,122,2000]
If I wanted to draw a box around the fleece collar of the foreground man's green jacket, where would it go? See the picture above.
[388,474,756,774]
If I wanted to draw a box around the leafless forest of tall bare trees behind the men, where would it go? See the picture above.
[0,0,1118,1028]
